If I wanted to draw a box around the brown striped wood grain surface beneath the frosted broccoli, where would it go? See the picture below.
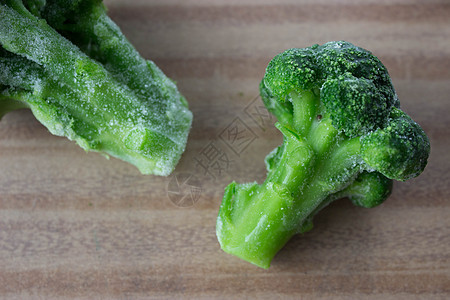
[0,0,450,299]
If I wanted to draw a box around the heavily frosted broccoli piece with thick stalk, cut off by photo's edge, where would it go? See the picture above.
[0,0,192,175]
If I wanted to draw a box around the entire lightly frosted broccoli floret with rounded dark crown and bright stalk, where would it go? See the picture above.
[217,41,430,268]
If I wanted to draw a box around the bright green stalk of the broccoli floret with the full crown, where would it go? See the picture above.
[217,102,360,268]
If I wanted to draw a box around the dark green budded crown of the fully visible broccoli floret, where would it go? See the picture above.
[261,41,430,181]
